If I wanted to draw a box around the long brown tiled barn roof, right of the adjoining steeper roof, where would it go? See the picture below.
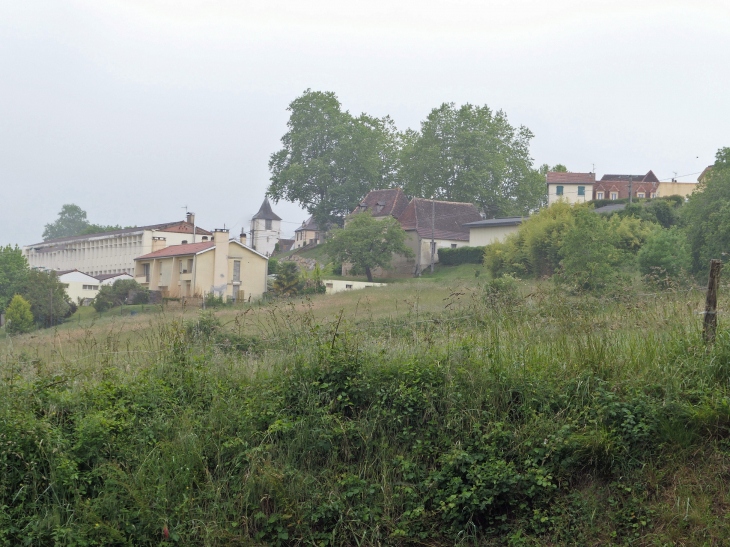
[398,198,482,241]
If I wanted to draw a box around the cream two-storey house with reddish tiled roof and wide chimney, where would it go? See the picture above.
[134,230,268,301]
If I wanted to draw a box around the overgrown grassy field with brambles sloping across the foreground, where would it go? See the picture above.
[0,272,730,546]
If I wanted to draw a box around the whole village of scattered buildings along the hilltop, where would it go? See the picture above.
[23,167,710,303]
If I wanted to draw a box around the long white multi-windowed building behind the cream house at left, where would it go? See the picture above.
[23,213,213,275]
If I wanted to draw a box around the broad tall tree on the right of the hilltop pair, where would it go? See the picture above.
[402,103,546,217]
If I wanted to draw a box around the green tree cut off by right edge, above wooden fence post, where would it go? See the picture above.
[681,147,730,273]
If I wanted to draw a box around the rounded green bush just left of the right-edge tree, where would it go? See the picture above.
[636,226,690,286]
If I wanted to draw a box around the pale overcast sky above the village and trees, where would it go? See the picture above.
[0,0,730,245]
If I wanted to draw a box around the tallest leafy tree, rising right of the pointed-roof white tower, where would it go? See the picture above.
[267,89,401,229]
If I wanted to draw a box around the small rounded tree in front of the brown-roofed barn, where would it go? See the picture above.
[325,211,413,281]
